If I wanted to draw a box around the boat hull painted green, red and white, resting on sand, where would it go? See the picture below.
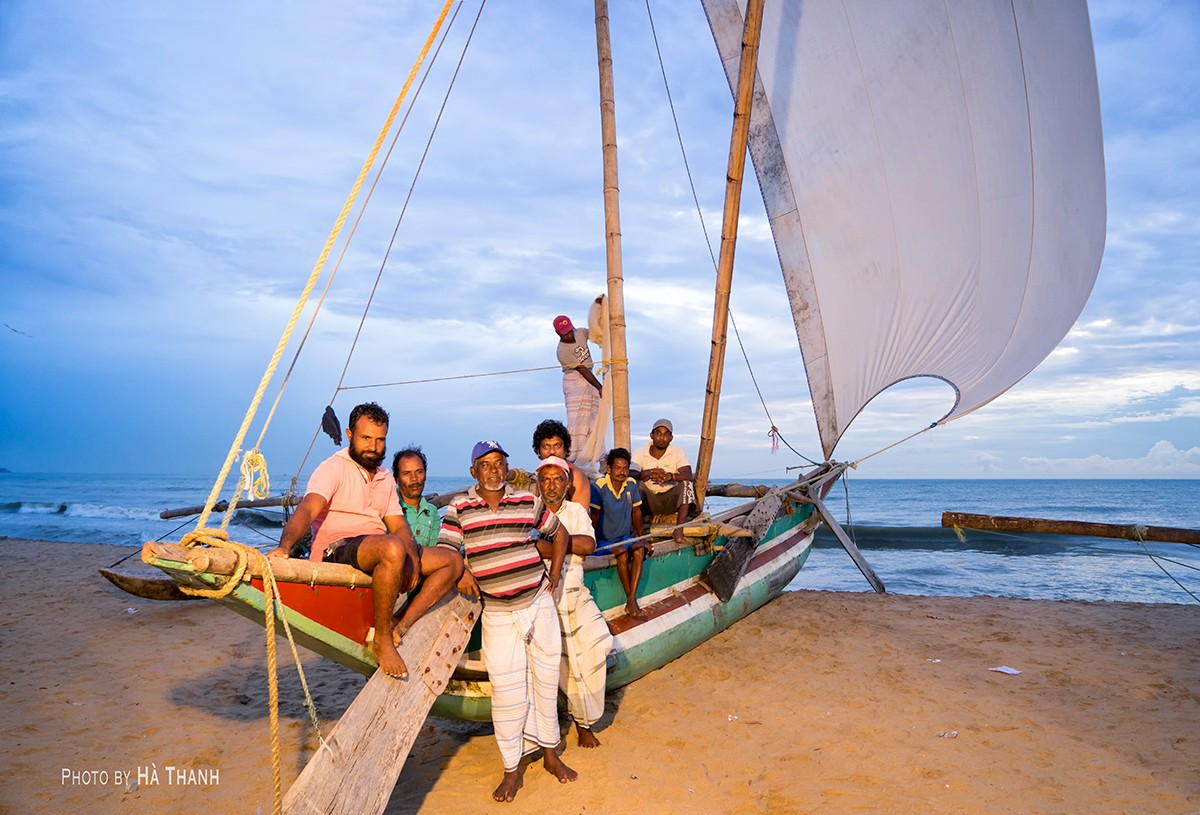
[143,484,816,721]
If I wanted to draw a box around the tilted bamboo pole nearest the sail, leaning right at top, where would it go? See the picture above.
[695,0,763,505]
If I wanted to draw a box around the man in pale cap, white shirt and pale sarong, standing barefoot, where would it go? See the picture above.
[538,456,612,748]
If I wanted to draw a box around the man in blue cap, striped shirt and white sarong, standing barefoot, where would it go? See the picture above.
[438,442,578,801]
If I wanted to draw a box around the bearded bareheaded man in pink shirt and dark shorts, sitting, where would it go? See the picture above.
[268,402,463,679]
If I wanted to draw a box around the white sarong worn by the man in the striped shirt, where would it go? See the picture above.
[482,586,563,773]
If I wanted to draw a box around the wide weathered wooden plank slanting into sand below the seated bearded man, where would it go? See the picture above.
[283,591,480,815]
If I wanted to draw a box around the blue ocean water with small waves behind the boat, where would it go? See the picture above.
[0,473,1200,603]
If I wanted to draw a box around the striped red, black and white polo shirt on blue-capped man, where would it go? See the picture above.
[438,484,559,610]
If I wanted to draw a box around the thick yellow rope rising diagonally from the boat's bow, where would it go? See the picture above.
[196,0,454,532]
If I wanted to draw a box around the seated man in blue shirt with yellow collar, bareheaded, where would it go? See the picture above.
[592,448,654,617]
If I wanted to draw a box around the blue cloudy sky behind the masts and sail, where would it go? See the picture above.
[0,0,1200,484]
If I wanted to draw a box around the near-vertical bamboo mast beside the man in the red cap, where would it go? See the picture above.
[595,0,631,450]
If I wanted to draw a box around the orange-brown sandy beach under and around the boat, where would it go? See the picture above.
[0,539,1200,815]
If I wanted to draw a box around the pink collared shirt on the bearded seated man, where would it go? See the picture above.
[306,450,404,561]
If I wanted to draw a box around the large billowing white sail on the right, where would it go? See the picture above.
[703,0,1105,456]
